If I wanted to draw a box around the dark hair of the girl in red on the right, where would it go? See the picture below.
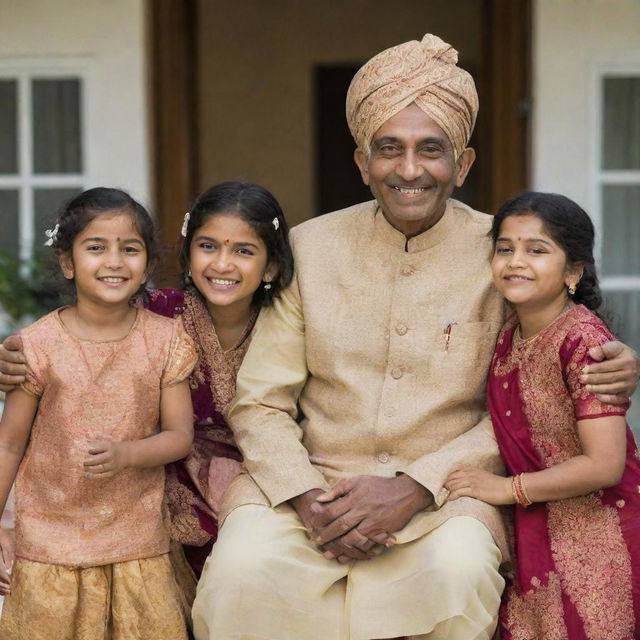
[490,191,602,315]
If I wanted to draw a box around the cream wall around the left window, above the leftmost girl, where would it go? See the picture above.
[0,0,151,203]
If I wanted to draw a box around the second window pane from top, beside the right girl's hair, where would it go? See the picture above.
[601,185,640,276]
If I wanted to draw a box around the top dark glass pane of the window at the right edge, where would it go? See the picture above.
[602,77,640,169]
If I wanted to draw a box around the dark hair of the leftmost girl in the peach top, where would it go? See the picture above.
[52,187,158,296]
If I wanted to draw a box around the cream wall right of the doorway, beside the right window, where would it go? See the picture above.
[532,0,640,210]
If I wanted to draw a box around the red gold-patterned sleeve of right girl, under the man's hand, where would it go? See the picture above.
[560,323,629,420]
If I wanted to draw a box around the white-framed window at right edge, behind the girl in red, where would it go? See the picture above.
[594,64,640,432]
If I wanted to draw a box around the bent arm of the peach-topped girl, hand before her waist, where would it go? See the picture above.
[84,380,193,478]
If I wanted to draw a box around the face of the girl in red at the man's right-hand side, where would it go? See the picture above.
[491,214,578,308]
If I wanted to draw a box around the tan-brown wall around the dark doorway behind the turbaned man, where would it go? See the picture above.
[198,0,481,222]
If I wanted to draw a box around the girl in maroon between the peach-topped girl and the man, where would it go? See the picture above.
[146,182,293,584]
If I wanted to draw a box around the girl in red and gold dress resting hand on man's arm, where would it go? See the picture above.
[447,193,640,640]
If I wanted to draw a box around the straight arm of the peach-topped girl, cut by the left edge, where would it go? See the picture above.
[0,388,38,595]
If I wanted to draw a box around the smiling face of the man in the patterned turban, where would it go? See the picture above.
[355,104,475,237]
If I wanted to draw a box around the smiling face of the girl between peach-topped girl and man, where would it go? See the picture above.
[189,212,273,311]
